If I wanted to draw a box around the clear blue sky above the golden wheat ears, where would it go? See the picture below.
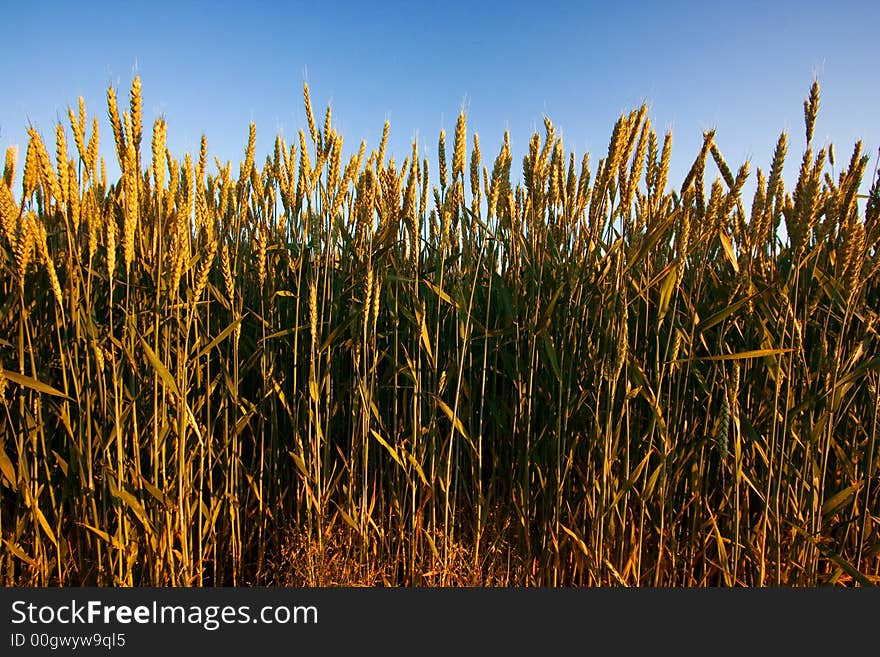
[0,0,880,197]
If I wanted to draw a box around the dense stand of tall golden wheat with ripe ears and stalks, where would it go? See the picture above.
[0,77,880,586]
